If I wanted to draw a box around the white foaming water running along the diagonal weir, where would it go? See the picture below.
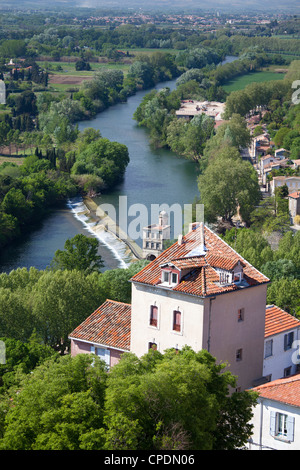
[68,198,130,268]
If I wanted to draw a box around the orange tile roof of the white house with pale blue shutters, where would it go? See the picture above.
[251,374,300,406]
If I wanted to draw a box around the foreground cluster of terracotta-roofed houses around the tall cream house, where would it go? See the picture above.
[69,221,300,450]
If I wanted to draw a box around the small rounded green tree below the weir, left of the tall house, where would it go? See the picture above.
[52,234,104,274]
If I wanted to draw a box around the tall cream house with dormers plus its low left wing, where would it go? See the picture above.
[69,224,269,390]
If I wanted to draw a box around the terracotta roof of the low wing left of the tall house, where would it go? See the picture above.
[69,300,131,351]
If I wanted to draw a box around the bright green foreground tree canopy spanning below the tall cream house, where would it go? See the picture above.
[0,347,256,451]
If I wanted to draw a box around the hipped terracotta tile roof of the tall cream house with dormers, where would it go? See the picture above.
[131,226,269,297]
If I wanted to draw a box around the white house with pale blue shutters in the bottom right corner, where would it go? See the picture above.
[247,374,300,450]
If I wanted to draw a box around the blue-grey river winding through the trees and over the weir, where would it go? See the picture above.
[0,57,238,272]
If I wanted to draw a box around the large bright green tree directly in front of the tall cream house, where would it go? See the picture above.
[105,347,254,450]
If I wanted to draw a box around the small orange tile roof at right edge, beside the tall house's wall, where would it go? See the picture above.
[265,305,300,338]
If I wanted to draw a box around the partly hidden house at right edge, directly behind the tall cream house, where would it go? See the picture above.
[263,305,300,381]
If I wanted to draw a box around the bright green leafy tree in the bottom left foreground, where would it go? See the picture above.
[0,355,107,450]
